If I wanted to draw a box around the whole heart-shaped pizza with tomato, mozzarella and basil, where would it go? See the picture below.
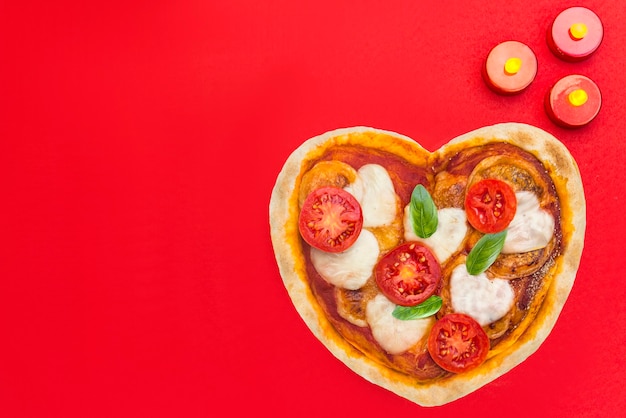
[270,123,586,406]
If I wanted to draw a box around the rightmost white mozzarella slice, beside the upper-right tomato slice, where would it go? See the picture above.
[502,191,554,254]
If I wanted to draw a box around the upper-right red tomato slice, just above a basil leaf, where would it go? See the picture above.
[465,179,517,234]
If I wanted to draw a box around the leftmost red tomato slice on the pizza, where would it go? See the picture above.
[298,187,363,253]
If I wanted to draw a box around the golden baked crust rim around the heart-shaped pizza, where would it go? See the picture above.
[269,123,586,406]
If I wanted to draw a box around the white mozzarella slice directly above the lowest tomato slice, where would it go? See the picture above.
[450,263,515,326]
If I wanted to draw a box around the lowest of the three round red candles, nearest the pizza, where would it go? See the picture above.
[545,74,602,128]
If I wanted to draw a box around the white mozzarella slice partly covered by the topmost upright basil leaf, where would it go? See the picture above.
[404,205,467,263]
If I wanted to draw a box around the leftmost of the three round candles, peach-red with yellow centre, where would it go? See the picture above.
[483,41,537,94]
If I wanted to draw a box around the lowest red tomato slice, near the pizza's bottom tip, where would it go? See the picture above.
[428,313,489,373]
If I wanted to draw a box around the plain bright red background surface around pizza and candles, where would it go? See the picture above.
[0,0,626,417]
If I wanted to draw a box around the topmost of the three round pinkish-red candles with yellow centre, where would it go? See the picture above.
[548,7,604,62]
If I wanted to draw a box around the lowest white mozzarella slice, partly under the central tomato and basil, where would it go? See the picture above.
[365,294,434,354]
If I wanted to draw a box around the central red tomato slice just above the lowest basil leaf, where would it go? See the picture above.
[374,242,441,306]
